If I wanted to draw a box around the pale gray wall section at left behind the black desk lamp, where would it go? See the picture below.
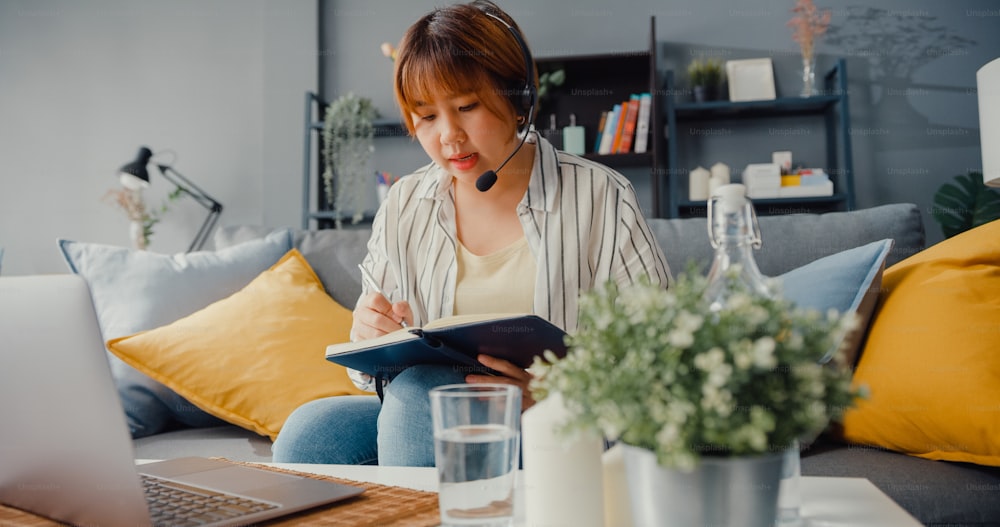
[0,0,318,274]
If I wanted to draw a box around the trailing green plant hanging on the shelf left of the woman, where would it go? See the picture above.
[322,93,378,227]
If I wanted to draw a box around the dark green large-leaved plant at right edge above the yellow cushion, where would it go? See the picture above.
[931,172,1000,238]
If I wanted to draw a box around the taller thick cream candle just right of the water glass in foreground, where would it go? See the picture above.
[521,394,604,527]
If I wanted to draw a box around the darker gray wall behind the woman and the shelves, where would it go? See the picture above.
[320,0,1000,246]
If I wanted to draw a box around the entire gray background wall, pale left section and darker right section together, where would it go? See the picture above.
[0,0,1000,274]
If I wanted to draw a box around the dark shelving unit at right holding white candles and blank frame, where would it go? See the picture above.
[665,59,854,217]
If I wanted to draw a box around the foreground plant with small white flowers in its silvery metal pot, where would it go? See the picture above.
[531,268,859,527]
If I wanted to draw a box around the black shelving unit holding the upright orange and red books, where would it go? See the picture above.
[535,17,664,217]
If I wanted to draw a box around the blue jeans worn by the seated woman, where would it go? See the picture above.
[272,365,465,467]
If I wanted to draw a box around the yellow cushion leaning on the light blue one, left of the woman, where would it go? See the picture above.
[108,249,366,440]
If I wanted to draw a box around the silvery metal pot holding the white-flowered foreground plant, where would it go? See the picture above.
[623,445,785,527]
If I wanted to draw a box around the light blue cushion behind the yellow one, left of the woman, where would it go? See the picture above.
[59,230,292,437]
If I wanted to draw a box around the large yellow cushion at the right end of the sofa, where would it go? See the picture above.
[843,221,1000,466]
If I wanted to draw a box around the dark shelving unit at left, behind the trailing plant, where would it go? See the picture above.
[302,92,406,229]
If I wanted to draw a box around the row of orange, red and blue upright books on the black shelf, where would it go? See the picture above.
[594,93,652,154]
